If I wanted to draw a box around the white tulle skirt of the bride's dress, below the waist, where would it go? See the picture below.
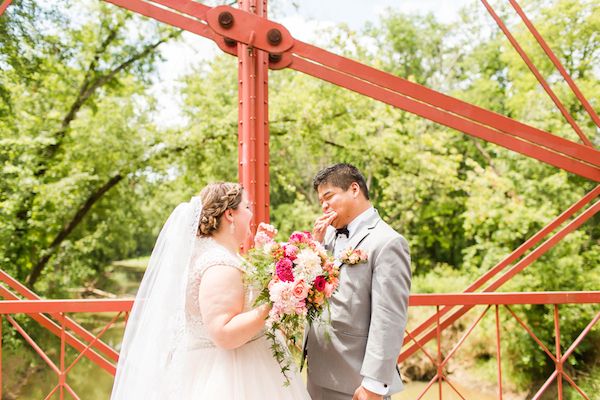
[165,336,310,400]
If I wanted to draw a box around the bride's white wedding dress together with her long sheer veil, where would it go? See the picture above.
[111,197,310,400]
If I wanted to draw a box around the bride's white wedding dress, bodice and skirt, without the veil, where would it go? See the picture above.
[168,238,310,400]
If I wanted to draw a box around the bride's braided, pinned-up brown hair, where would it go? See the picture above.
[198,182,243,236]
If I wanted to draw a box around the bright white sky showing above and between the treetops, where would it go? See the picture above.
[152,0,478,126]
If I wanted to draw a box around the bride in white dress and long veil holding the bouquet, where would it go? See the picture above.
[111,183,310,400]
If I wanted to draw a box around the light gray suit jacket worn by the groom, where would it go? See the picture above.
[305,213,411,395]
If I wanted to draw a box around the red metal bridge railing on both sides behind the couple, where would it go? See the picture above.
[0,278,600,399]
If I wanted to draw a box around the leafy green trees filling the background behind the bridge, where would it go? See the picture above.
[0,0,600,396]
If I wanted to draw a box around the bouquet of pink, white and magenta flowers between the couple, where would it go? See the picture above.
[246,223,339,383]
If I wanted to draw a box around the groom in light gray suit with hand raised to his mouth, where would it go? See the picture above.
[305,164,411,400]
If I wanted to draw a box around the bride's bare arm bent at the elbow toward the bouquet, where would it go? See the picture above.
[199,266,270,349]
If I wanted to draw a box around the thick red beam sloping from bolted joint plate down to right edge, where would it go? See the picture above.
[207,6,600,181]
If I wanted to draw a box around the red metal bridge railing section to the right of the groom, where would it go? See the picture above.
[406,291,600,400]
